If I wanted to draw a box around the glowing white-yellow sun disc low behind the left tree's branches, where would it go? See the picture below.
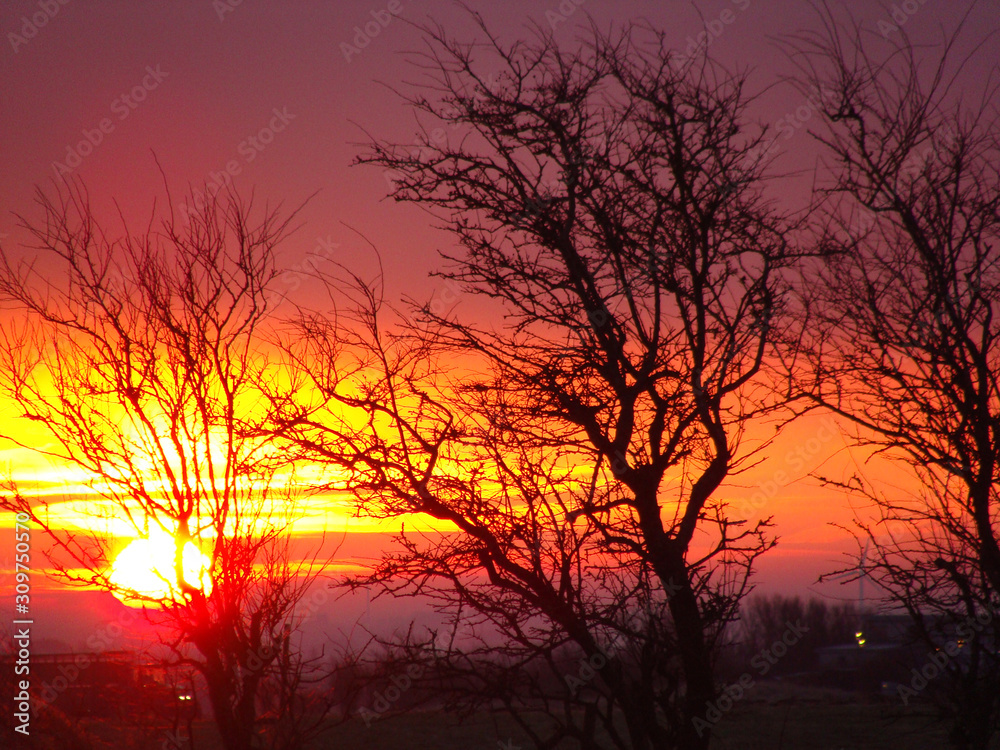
[109,531,212,604]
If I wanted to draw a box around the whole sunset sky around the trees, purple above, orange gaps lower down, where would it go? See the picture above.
[0,0,1000,645]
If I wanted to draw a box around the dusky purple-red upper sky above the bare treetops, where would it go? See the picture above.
[0,0,1000,293]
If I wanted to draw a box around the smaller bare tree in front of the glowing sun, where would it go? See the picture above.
[0,185,336,750]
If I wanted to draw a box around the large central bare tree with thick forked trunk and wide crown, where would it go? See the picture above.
[272,18,791,748]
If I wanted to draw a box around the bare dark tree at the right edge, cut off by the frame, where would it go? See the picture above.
[794,8,1000,748]
